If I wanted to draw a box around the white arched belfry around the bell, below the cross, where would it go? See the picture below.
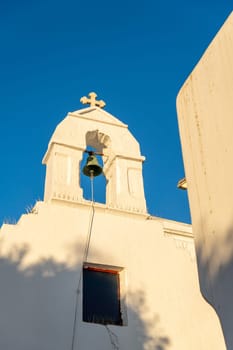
[43,107,147,213]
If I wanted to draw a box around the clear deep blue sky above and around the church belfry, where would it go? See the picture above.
[0,0,233,226]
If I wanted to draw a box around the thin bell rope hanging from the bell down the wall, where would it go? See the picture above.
[71,174,95,350]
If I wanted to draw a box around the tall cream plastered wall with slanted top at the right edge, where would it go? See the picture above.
[177,13,233,349]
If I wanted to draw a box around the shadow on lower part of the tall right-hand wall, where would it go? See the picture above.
[196,220,233,349]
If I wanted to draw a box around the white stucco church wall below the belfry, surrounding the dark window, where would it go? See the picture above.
[0,201,224,350]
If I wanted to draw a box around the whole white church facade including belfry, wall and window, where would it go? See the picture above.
[0,94,226,350]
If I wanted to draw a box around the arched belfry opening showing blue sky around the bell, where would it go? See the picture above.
[80,146,106,203]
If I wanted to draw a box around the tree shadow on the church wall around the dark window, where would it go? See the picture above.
[0,248,169,350]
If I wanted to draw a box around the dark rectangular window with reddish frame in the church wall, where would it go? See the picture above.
[83,263,123,326]
